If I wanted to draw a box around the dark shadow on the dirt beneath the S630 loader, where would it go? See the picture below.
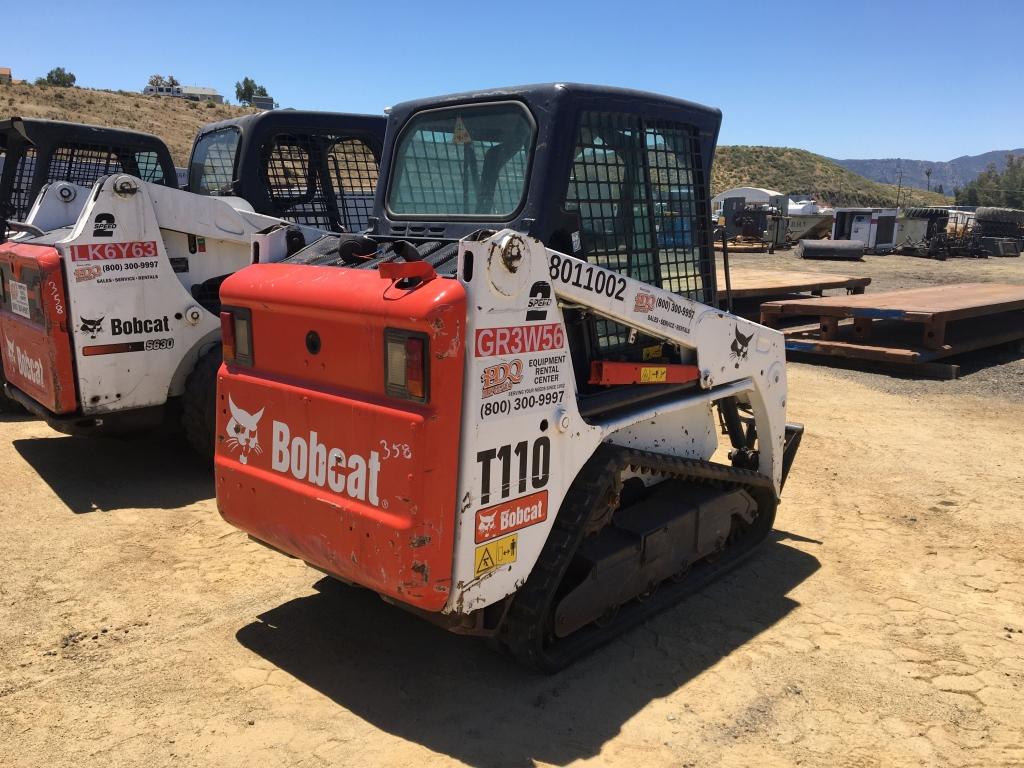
[12,432,214,514]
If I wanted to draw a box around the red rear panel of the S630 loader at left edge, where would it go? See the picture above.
[0,243,78,414]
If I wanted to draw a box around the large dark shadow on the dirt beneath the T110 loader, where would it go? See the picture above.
[236,535,820,768]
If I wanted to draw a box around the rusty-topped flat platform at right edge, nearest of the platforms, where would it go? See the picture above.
[761,283,1024,376]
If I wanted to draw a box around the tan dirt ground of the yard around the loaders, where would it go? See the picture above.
[0,255,1024,768]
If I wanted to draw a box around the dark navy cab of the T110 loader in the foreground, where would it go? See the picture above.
[372,84,721,392]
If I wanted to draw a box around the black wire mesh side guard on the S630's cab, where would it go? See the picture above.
[264,134,378,231]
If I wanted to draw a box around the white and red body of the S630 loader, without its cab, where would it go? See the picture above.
[0,174,324,453]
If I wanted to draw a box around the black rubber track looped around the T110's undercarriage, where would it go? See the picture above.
[499,443,775,674]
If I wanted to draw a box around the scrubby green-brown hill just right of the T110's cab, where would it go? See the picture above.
[712,146,952,206]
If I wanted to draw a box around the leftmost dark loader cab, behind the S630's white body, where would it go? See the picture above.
[0,117,178,221]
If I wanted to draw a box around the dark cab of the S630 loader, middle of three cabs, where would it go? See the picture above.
[187,110,387,232]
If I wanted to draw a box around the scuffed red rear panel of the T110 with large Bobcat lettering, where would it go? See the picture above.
[215,264,466,611]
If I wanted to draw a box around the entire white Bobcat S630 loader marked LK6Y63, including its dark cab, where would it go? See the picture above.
[0,111,384,459]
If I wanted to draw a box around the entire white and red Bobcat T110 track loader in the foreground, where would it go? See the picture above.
[215,84,802,671]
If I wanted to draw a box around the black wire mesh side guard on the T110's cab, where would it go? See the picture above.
[565,112,714,350]
